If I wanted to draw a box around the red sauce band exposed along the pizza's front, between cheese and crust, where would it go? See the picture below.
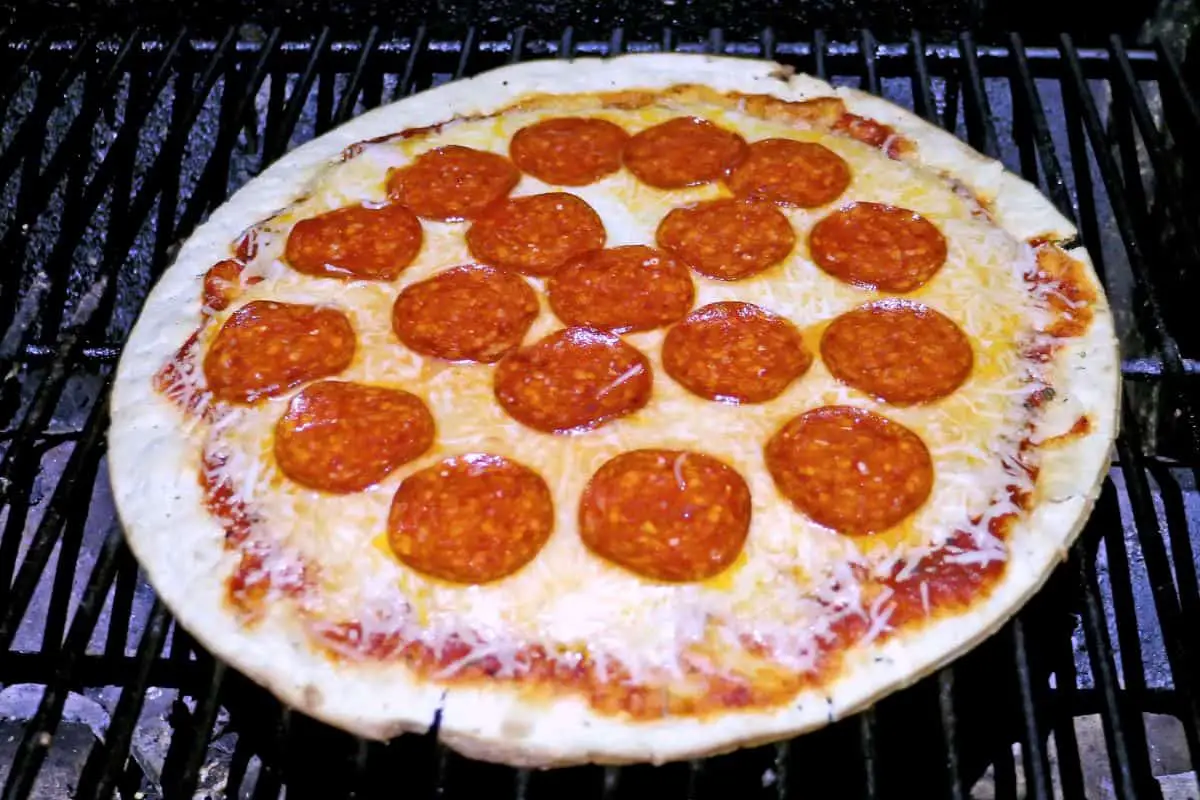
[171,299,1070,720]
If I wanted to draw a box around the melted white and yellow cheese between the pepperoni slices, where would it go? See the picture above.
[182,100,1045,680]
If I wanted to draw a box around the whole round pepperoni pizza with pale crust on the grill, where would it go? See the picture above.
[109,54,1120,766]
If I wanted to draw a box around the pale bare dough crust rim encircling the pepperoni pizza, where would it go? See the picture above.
[109,54,1120,766]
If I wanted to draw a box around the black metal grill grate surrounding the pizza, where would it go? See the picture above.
[0,25,1200,800]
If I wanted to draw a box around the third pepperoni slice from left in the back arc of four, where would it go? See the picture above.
[623,116,746,188]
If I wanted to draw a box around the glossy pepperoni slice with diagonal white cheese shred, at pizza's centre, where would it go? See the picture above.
[496,327,654,433]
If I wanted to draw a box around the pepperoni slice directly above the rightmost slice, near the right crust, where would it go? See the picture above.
[809,203,946,294]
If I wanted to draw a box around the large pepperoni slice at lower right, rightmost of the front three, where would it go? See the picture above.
[766,405,934,534]
